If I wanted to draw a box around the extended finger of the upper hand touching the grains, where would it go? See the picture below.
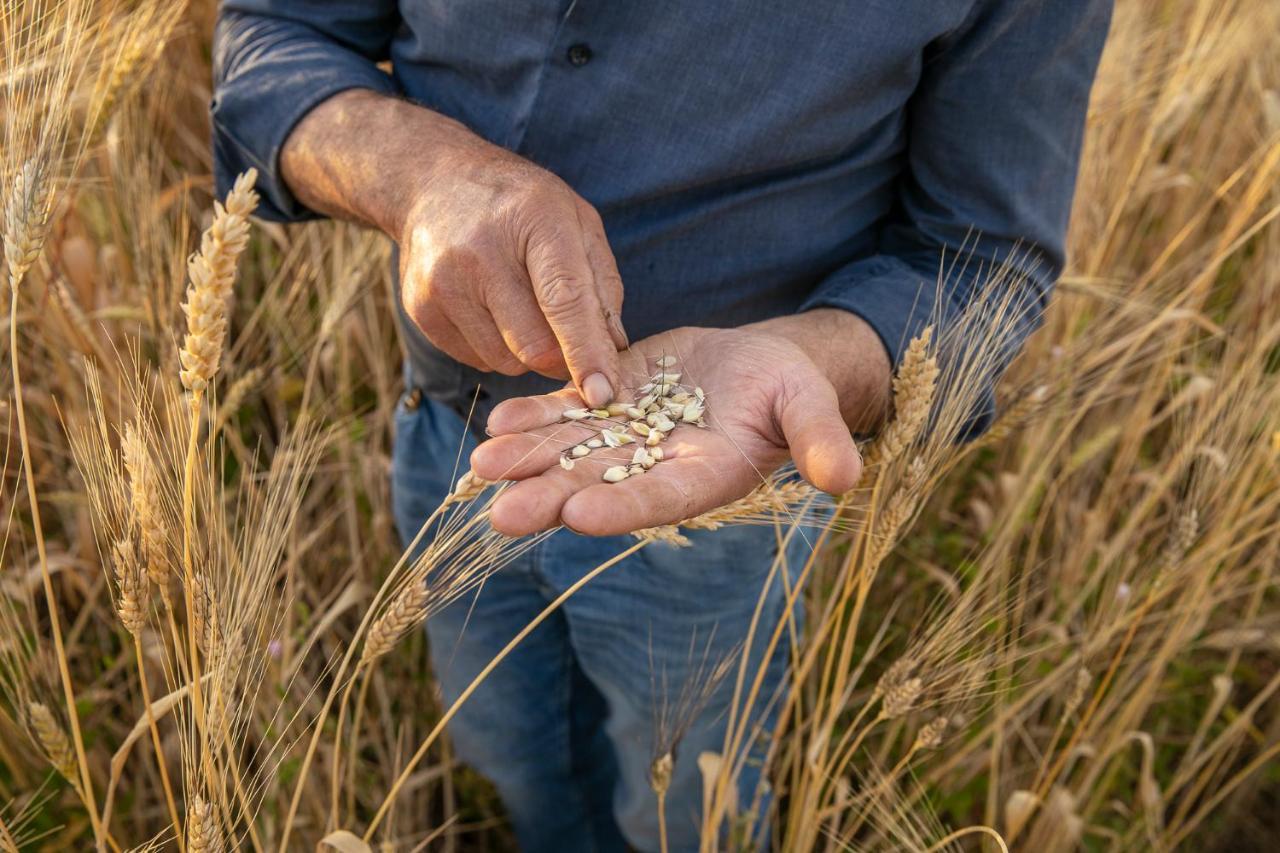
[525,214,621,409]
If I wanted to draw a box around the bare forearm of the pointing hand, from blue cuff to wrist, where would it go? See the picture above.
[280,88,489,240]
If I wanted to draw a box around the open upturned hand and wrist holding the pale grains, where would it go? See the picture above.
[471,310,888,535]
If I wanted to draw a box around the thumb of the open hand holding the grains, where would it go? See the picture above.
[778,371,863,494]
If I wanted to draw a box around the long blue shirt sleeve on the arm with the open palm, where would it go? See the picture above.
[803,0,1111,434]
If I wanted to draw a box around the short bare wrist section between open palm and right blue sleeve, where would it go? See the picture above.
[748,309,892,433]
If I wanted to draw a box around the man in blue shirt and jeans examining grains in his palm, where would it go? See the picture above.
[212,0,1110,850]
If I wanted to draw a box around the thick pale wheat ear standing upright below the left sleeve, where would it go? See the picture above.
[178,169,257,393]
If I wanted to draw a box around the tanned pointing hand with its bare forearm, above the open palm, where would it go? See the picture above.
[280,90,627,406]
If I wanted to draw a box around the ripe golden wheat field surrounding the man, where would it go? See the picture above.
[0,0,1280,853]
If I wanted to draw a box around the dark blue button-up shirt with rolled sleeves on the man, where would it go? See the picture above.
[212,0,1111,428]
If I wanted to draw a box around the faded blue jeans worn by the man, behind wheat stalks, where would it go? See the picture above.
[393,389,808,853]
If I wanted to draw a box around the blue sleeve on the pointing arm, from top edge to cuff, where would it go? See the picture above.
[210,0,399,222]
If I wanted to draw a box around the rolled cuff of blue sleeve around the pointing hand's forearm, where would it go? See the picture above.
[210,14,399,222]
